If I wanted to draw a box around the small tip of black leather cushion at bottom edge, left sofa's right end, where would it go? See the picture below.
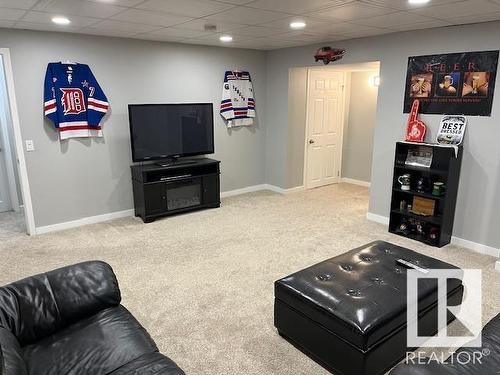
[110,353,184,375]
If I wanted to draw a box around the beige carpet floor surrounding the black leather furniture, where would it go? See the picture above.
[0,184,500,375]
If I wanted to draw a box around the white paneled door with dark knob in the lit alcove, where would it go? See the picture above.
[305,69,345,189]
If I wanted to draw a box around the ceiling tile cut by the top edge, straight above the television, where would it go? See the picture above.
[137,0,234,18]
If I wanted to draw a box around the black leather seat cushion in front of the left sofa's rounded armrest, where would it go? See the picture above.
[23,305,158,375]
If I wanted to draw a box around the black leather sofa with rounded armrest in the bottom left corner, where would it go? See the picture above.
[0,261,184,375]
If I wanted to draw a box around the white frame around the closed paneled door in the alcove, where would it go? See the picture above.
[302,67,347,190]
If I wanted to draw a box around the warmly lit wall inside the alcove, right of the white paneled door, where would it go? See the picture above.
[342,71,378,182]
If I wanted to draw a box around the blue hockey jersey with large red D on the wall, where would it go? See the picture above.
[44,62,109,140]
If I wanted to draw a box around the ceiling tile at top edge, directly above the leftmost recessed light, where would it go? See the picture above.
[33,0,125,18]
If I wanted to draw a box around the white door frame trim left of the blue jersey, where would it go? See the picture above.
[0,48,36,235]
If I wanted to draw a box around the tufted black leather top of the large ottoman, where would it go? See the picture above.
[275,241,461,351]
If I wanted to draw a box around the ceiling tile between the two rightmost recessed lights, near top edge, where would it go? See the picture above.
[309,2,395,21]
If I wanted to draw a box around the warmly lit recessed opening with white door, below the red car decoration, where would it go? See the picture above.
[289,62,380,189]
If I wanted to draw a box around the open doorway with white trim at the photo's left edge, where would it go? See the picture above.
[0,48,34,236]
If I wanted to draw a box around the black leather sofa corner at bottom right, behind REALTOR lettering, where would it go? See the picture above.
[391,314,500,375]
